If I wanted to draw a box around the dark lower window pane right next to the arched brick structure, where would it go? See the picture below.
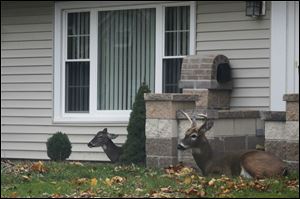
[163,58,183,93]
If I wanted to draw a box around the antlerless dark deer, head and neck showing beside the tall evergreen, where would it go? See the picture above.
[88,128,122,163]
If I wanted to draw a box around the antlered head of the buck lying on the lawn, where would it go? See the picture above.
[177,111,214,150]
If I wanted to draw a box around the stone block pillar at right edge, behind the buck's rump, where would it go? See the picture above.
[265,94,299,169]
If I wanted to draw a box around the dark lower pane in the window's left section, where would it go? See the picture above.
[66,62,90,112]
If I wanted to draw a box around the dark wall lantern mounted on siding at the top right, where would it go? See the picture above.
[246,1,266,17]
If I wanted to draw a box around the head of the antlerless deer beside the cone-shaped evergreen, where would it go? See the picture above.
[88,128,118,148]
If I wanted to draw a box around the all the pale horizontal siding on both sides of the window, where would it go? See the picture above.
[1,1,270,161]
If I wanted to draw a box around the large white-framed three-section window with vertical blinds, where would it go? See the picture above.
[54,2,195,121]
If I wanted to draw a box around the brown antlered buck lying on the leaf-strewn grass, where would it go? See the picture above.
[177,111,287,178]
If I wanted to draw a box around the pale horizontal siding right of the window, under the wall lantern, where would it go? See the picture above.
[196,1,270,110]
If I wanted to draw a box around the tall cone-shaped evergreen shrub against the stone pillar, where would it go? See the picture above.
[120,83,151,164]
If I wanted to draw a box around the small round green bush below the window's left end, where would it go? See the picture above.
[46,132,72,161]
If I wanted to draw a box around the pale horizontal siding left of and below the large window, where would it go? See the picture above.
[1,1,127,161]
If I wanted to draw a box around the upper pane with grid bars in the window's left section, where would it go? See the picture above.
[67,12,90,59]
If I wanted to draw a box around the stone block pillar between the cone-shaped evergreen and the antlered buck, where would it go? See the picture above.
[144,94,198,167]
